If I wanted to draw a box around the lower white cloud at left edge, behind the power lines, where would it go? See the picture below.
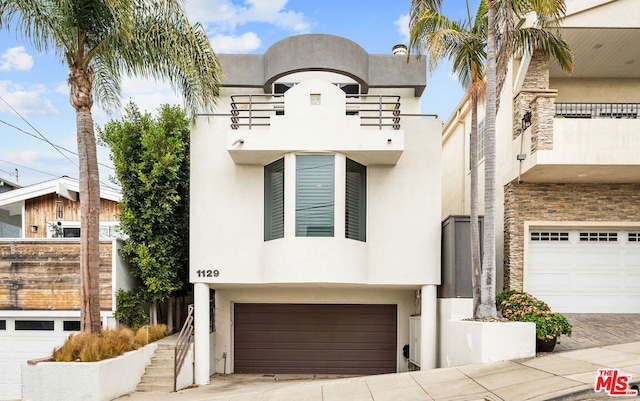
[0,81,60,117]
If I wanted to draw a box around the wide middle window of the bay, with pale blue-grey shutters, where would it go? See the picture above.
[296,155,335,237]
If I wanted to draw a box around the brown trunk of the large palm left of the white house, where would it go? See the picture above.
[69,67,100,334]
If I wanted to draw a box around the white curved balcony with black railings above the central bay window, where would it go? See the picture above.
[227,91,404,165]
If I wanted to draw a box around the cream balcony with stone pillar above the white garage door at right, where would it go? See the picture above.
[511,103,640,183]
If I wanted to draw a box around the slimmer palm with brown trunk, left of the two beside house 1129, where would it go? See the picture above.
[409,0,486,317]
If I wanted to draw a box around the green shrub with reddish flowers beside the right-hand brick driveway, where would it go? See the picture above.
[496,290,573,340]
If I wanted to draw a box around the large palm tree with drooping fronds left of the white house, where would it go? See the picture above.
[0,0,221,333]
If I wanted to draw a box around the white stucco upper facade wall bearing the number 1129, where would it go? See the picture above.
[190,76,441,287]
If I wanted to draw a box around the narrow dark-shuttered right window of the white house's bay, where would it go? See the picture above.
[345,159,367,241]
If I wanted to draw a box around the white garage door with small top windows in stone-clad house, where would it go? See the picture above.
[525,229,640,313]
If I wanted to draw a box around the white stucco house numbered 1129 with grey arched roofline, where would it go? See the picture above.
[190,34,442,384]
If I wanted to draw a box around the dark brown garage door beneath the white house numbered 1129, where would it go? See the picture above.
[233,304,397,375]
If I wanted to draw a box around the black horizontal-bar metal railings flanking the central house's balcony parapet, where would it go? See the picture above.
[231,94,400,130]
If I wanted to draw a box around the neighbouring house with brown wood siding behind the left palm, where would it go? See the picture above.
[0,177,132,400]
